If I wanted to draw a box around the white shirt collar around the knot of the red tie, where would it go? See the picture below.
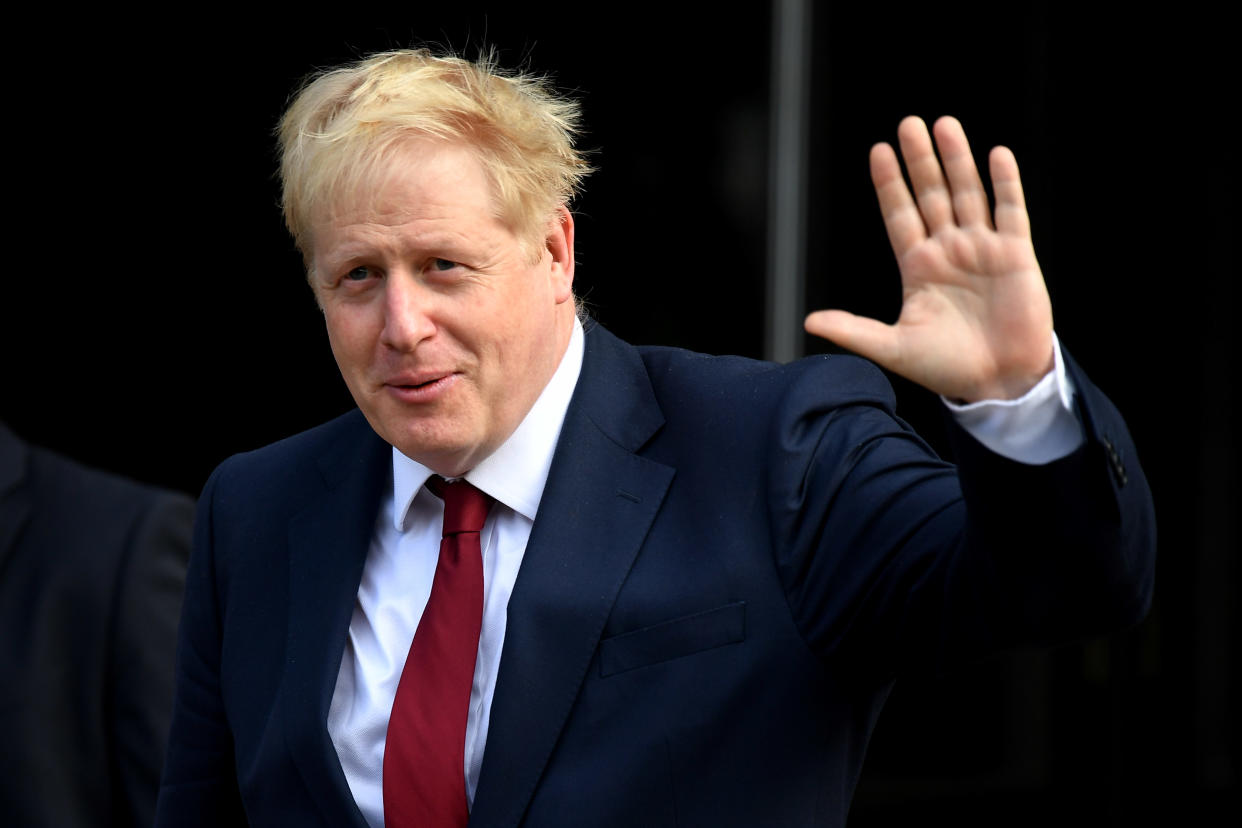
[392,319,585,533]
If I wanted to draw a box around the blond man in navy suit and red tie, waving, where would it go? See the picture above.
[158,51,1154,828]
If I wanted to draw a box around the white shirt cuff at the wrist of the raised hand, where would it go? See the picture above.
[940,333,1086,466]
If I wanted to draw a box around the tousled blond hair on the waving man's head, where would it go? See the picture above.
[278,48,590,263]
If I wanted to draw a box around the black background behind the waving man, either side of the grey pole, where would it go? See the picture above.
[0,2,1242,826]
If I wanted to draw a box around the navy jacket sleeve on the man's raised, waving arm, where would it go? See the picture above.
[769,358,1155,677]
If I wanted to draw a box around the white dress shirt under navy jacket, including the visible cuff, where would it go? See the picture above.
[328,320,1083,828]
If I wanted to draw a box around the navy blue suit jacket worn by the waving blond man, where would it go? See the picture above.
[156,328,1154,827]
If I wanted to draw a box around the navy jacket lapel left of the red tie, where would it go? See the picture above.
[281,412,391,827]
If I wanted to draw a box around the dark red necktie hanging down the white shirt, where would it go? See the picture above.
[384,477,492,828]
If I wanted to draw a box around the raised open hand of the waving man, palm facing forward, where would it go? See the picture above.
[806,117,1053,401]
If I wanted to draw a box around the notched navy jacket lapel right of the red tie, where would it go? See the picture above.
[471,328,673,827]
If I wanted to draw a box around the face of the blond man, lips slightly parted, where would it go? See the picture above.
[311,139,574,477]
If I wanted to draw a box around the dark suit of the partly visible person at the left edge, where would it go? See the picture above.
[0,425,194,828]
